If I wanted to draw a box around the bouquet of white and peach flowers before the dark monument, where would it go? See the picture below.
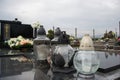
[7,36,33,49]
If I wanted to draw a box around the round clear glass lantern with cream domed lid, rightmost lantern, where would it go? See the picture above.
[73,34,100,79]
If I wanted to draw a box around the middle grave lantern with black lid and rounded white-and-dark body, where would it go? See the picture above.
[52,31,74,67]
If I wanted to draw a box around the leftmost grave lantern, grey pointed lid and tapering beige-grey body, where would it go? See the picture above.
[34,26,50,60]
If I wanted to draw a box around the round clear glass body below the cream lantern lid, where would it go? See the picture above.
[74,51,99,74]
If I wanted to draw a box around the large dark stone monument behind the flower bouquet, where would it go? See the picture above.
[0,18,33,42]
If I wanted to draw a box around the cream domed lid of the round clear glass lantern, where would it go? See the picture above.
[79,34,94,51]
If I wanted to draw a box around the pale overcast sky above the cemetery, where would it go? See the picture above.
[0,0,120,35]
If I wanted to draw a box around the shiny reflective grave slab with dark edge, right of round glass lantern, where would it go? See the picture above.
[96,51,120,73]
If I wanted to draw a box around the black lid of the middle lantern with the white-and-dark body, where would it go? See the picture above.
[58,31,70,44]
